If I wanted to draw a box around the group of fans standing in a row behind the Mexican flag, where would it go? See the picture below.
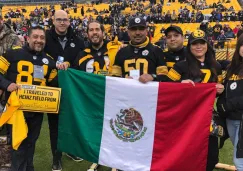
[0,5,243,171]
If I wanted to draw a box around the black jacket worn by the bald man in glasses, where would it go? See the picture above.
[44,27,84,65]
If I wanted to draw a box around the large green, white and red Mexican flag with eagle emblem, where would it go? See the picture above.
[58,69,216,171]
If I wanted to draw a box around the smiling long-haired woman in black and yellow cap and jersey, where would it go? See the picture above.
[168,30,224,171]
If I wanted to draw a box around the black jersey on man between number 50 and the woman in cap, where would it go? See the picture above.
[164,47,186,69]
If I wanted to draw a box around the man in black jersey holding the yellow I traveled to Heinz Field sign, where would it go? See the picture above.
[0,26,57,171]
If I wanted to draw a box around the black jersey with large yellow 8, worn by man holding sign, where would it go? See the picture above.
[0,46,57,86]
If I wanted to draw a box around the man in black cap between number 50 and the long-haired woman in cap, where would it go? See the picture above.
[164,25,186,69]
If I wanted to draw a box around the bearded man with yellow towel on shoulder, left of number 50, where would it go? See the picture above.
[74,21,121,171]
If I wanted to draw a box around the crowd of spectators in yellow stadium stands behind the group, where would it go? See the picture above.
[1,0,243,49]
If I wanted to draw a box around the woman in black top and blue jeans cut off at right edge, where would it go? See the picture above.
[217,35,243,171]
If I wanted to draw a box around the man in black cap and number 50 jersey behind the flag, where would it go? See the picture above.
[112,17,168,83]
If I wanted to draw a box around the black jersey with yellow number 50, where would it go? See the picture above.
[112,40,168,81]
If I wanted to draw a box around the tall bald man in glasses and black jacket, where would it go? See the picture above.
[45,10,84,171]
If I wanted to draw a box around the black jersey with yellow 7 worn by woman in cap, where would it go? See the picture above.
[167,61,223,83]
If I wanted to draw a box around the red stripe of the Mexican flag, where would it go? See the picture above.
[151,83,216,171]
